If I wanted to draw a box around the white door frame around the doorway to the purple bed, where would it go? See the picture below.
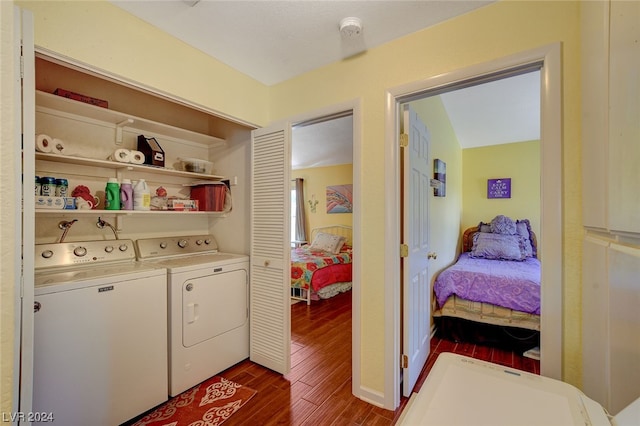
[384,43,564,408]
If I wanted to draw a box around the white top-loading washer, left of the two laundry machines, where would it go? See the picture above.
[33,240,168,426]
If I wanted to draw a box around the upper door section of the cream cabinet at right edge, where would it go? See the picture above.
[580,1,640,234]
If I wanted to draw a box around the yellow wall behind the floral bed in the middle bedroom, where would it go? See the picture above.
[291,164,353,238]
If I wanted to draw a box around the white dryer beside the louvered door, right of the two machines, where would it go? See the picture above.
[136,235,249,396]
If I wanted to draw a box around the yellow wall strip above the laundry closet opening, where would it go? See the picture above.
[15,0,269,126]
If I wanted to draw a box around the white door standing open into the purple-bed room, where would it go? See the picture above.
[401,105,433,397]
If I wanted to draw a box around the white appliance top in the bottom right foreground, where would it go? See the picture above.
[398,353,640,426]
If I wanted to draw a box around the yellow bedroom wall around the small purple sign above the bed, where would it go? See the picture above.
[462,141,540,237]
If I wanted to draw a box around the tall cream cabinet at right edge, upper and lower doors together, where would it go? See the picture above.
[580,0,640,415]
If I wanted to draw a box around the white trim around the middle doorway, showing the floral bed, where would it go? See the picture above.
[287,98,360,400]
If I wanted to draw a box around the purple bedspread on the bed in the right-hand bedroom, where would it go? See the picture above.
[434,253,540,315]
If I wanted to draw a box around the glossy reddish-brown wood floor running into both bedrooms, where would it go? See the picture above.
[220,292,540,426]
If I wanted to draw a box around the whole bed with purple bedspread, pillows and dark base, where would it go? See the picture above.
[433,220,540,344]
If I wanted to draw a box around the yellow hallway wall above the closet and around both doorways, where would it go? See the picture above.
[0,1,582,412]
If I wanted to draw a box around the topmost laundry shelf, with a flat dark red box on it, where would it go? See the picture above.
[36,90,226,147]
